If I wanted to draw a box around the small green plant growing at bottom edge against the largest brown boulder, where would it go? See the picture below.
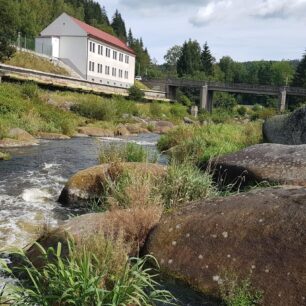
[220,275,262,306]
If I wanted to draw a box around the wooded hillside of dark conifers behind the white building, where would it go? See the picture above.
[0,0,151,76]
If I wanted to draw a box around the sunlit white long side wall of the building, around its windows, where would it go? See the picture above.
[87,38,135,87]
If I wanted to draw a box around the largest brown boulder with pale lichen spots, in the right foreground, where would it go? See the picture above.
[146,187,306,306]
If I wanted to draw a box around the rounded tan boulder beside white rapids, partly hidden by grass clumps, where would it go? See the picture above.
[59,163,166,206]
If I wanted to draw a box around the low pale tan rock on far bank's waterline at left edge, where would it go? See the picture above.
[0,128,38,148]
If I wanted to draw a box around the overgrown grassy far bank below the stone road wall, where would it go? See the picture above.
[0,83,187,139]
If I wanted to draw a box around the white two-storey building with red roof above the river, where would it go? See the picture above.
[35,13,135,87]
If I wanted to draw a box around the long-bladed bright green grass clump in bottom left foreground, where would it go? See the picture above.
[1,243,173,306]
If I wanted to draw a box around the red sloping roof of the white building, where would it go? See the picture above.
[71,17,135,54]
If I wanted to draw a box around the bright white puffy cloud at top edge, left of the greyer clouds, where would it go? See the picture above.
[189,0,232,26]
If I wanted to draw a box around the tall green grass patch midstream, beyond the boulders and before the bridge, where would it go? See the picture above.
[158,123,262,163]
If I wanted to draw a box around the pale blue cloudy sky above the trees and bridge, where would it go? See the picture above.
[98,0,306,64]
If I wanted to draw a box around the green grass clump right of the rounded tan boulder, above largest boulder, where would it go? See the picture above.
[160,162,216,209]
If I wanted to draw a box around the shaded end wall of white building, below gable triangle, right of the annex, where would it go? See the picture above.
[59,36,87,79]
